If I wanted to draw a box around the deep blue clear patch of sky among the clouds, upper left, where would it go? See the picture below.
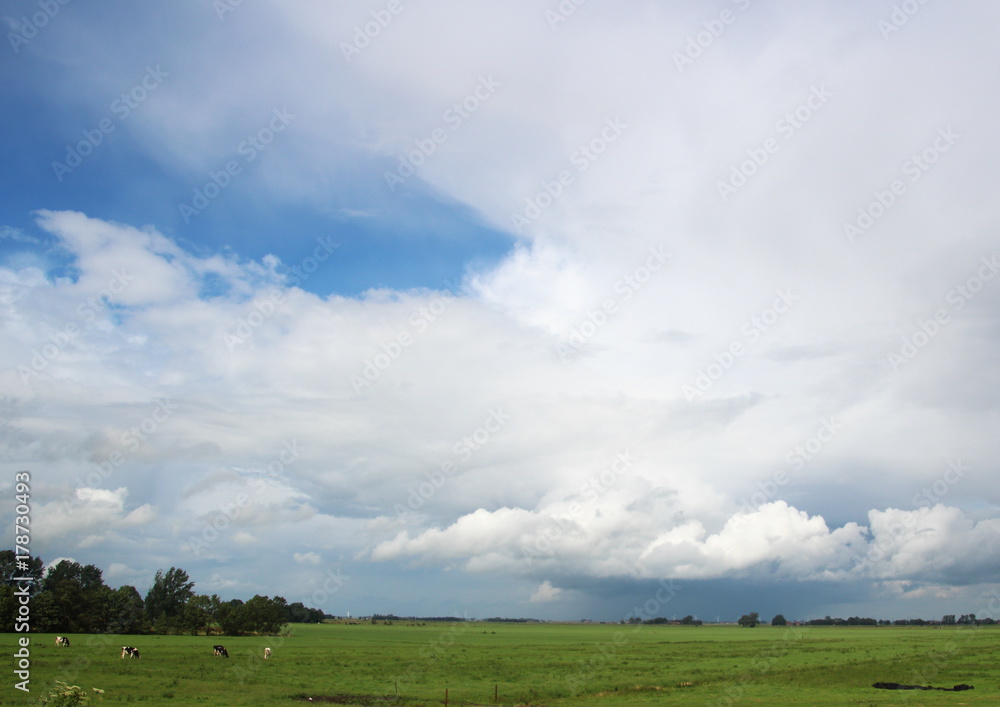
[0,3,513,295]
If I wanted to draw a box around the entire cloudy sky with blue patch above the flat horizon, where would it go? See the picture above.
[0,0,1000,621]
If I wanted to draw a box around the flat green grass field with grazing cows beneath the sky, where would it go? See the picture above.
[0,621,1000,707]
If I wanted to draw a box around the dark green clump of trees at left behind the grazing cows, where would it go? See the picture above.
[0,550,325,636]
